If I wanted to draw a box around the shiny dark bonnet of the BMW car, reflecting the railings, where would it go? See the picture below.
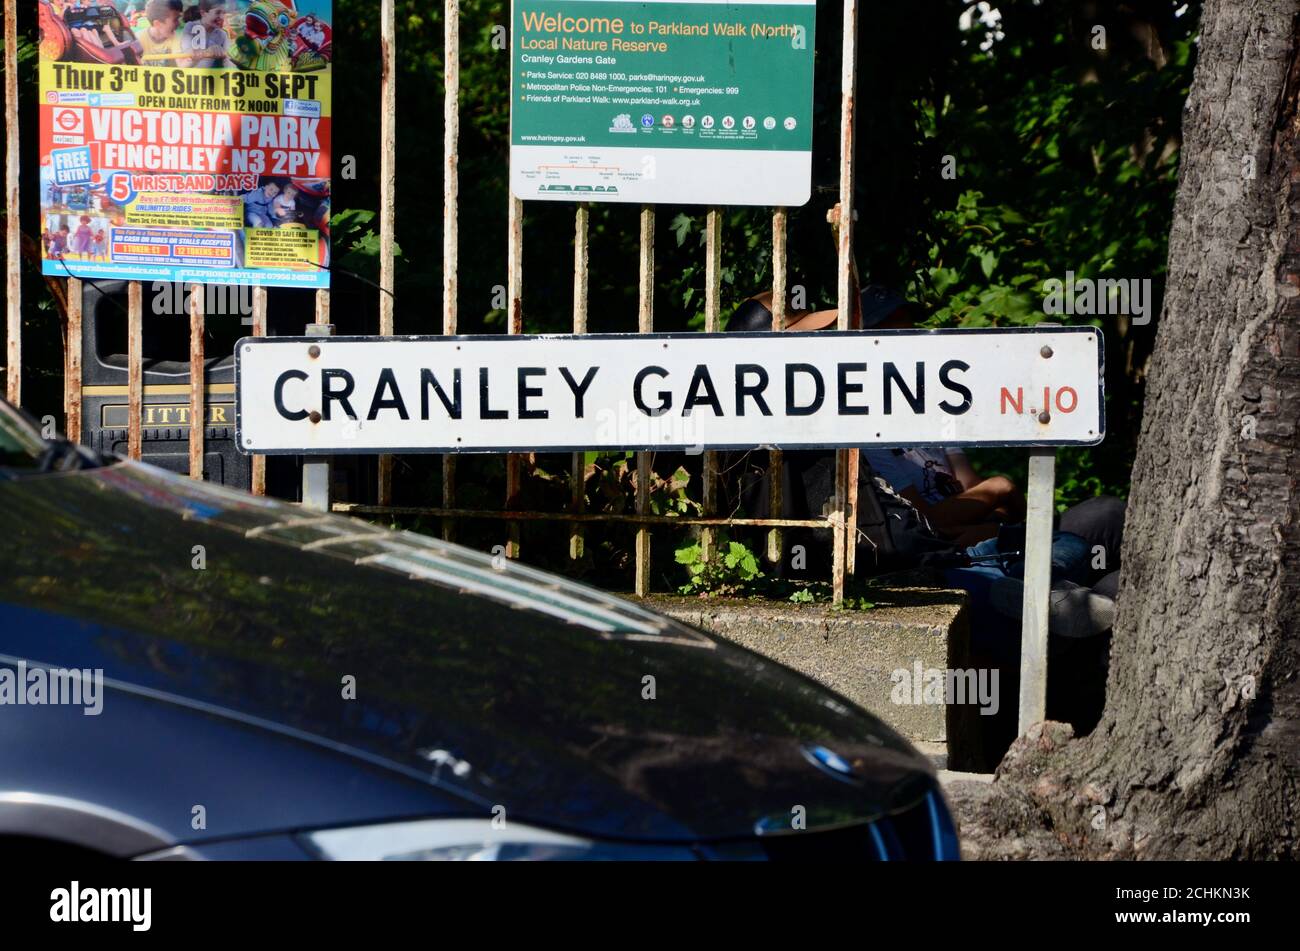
[0,464,932,841]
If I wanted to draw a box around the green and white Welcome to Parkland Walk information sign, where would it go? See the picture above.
[510,0,816,205]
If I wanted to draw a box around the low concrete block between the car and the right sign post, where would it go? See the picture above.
[646,586,1005,769]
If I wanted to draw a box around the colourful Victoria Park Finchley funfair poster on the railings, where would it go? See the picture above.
[36,0,333,287]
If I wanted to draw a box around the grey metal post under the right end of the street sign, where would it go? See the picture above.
[1019,448,1056,737]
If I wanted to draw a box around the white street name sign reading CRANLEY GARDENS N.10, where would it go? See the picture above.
[235,327,1105,456]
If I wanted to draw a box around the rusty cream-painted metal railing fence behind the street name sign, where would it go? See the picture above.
[4,0,858,600]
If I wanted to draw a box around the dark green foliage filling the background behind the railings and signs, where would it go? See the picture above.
[0,0,1201,587]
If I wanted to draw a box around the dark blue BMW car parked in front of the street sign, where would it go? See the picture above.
[0,405,957,860]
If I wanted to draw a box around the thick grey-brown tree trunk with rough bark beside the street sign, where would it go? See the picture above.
[953,0,1300,859]
